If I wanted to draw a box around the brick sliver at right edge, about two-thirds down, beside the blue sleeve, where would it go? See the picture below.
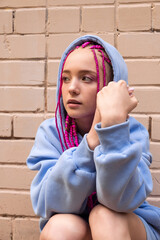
[150,142,160,169]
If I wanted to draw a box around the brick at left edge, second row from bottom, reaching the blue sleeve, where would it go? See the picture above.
[0,190,35,216]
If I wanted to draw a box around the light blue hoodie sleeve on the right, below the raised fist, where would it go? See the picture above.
[94,117,152,212]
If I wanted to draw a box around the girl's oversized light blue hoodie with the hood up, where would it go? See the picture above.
[27,35,160,231]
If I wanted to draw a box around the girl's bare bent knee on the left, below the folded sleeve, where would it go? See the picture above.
[40,214,92,240]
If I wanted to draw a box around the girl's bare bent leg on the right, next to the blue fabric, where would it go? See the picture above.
[89,205,147,240]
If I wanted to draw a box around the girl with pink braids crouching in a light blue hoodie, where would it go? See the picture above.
[27,35,160,240]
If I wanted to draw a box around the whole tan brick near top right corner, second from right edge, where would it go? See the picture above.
[117,5,151,31]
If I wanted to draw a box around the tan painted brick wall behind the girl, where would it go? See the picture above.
[0,0,160,240]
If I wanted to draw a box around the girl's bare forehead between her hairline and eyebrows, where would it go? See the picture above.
[64,47,96,70]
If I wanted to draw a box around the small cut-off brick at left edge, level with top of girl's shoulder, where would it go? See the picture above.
[0,114,12,137]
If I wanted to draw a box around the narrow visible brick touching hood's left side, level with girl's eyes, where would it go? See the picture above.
[48,60,60,85]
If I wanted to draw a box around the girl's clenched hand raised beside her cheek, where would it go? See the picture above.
[97,80,138,127]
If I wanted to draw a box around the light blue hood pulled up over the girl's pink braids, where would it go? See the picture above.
[56,35,128,151]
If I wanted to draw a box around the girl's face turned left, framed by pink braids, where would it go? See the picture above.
[62,47,102,133]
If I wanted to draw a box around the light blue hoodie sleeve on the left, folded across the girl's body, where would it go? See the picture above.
[27,119,96,219]
